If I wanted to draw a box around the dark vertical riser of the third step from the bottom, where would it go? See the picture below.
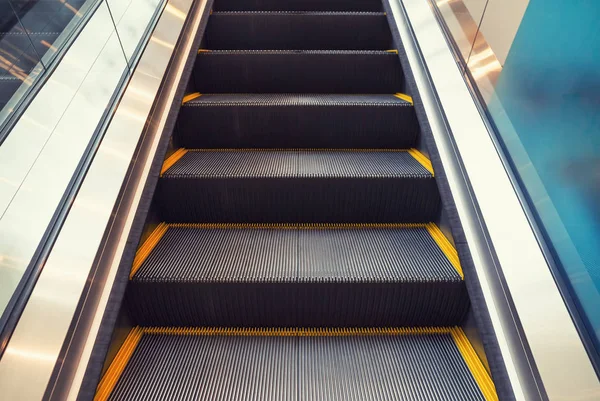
[158,177,440,223]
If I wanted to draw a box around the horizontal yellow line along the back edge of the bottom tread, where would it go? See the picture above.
[143,327,451,337]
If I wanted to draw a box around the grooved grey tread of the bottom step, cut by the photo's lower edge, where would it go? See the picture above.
[110,334,485,401]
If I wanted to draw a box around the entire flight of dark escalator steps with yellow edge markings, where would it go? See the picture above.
[95,0,498,401]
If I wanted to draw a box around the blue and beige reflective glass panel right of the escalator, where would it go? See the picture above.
[437,0,600,355]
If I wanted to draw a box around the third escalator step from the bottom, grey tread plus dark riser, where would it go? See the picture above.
[157,149,440,223]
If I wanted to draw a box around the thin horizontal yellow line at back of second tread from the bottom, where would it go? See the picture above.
[168,223,426,230]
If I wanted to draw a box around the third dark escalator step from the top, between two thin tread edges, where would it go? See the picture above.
[193,50,405,94]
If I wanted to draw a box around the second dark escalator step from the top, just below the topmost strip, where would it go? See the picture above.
[204,11,393,50]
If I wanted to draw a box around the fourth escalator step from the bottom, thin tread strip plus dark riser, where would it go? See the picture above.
[175,94,419,149]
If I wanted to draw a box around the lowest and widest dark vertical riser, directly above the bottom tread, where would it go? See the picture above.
[127,280,469,327]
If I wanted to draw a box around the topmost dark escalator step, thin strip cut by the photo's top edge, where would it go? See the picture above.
[214,0,383,11]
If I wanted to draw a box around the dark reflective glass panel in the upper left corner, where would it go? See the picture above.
[0,0,98,129]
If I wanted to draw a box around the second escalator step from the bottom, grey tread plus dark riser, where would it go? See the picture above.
[127,224,469,327]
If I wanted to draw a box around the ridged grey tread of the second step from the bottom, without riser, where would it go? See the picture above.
[133,224,462,283]
